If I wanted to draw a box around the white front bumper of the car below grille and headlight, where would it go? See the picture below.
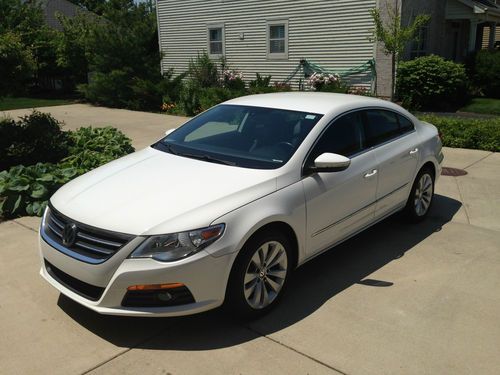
[39,236,236,317]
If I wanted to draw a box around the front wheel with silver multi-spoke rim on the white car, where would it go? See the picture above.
[226,231,293,318]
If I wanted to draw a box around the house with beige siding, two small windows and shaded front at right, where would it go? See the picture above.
[157,0,500,96]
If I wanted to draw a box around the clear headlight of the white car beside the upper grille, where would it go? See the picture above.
[130,224,225,262]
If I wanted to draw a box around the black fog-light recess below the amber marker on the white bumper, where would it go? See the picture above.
[122,286,194,307]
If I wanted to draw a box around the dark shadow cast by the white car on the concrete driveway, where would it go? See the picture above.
[58,195,461,351]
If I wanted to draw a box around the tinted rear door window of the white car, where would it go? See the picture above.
[366,109,400,146]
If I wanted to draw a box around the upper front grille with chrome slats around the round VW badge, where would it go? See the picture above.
[45,207,133,264]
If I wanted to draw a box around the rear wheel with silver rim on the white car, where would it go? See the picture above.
[404,167,435,223]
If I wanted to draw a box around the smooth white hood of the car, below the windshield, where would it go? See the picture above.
[50,147,276,235]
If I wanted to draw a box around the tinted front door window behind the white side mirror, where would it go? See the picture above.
[310,112,365,161]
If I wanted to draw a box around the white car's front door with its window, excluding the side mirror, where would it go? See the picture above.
[302,112,378,255]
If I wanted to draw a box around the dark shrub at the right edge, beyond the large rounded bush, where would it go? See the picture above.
[473,50,500,98]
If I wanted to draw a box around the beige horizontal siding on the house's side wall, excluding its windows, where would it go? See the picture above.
[157,0,376,89]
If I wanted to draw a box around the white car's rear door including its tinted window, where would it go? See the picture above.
[365,109,419,219]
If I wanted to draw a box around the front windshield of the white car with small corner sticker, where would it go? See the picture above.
[153,104,322,169]
